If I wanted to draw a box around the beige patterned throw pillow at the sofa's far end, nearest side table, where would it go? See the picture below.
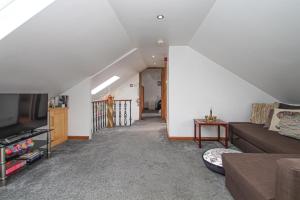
[250,103,275,124]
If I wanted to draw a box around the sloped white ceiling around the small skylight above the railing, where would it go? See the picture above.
[91,49,147,100]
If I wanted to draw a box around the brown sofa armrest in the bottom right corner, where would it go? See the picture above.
[275,158,300,200]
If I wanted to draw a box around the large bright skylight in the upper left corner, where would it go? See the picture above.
[0,0,56,40]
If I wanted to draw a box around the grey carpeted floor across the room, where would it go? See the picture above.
[0,118,232,200]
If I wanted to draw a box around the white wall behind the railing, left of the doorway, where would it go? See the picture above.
[111,74,139,123]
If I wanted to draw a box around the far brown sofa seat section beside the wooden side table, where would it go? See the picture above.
[230,123,300,154]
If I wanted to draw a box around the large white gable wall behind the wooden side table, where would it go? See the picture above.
[168,46,276,137]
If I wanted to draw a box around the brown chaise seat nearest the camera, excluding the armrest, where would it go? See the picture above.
[222,153,300,200]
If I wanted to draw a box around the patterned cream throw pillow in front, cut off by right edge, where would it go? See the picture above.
[279,112,300,140]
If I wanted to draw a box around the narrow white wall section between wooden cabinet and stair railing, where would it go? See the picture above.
[63,79,92,138]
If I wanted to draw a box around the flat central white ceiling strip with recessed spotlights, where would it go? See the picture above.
[109,0,215,67]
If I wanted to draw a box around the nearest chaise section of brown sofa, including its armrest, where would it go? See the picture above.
[223,153,300,200]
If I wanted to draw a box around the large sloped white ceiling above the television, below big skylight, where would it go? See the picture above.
[0,0,133,94]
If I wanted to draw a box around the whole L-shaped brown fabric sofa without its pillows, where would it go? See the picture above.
[223,122,300,200]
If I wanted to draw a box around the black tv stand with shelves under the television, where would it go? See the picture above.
[0,129,51,183]
